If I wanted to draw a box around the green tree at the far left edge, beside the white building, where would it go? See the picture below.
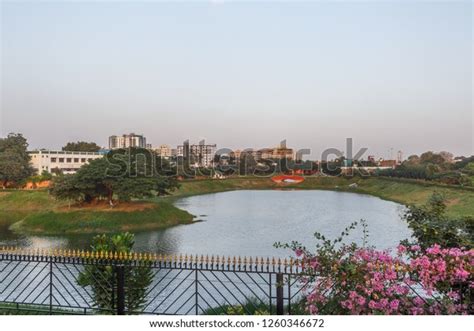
[0,133,35,188]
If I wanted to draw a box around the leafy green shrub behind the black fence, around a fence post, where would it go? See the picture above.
[77,232,153,313]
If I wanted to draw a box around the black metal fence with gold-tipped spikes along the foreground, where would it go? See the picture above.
[0,248,301,315]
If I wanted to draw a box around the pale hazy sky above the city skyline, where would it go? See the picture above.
[0,1,473,158]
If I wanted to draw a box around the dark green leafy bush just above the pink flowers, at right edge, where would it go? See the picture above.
[404,192,474,248]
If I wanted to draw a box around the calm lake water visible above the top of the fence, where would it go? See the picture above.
[0,190,410,257]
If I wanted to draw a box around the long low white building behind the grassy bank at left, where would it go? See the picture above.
[28,150,105,174]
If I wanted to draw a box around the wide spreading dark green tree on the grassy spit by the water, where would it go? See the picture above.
[51,148,177,205]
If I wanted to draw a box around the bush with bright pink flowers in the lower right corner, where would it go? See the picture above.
[279,222,474,315]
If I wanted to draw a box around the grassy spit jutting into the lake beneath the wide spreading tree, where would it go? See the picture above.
[0,191,193,235]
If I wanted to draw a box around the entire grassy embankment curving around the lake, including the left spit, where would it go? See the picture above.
[0,177,474,234]
